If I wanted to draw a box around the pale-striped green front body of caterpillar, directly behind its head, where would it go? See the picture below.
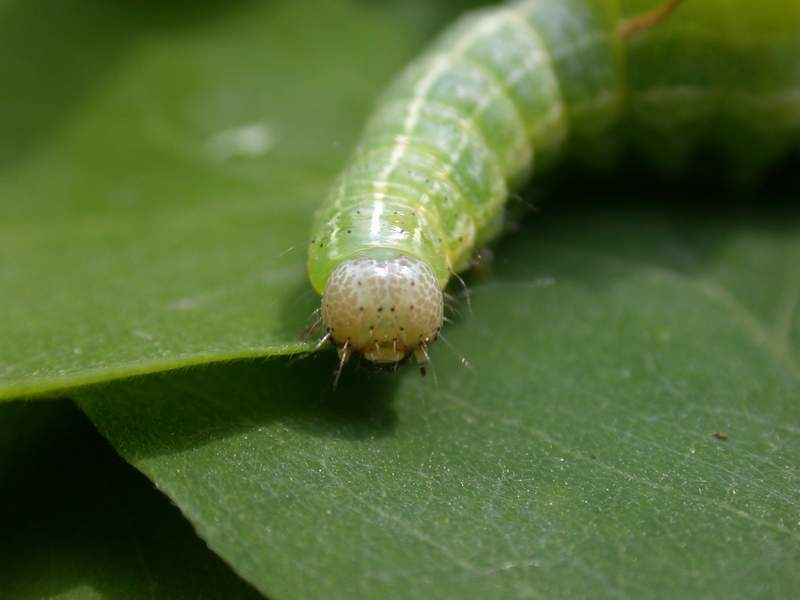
[309,0,622,292]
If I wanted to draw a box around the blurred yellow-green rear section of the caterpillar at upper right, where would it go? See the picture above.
[620,0,800,173]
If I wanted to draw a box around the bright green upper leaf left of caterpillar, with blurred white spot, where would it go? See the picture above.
[0,0,478,398]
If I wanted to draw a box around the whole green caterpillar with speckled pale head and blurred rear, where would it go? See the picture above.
[308,0,800,370]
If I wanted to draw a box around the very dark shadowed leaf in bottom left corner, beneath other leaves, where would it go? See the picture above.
[0,401,260,598]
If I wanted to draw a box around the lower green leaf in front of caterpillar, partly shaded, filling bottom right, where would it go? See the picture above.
[80,196,800,598]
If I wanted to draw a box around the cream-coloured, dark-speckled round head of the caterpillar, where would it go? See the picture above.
[322,256,443,363]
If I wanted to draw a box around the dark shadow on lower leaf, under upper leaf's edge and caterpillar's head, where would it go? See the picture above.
[80,351,398,458]
